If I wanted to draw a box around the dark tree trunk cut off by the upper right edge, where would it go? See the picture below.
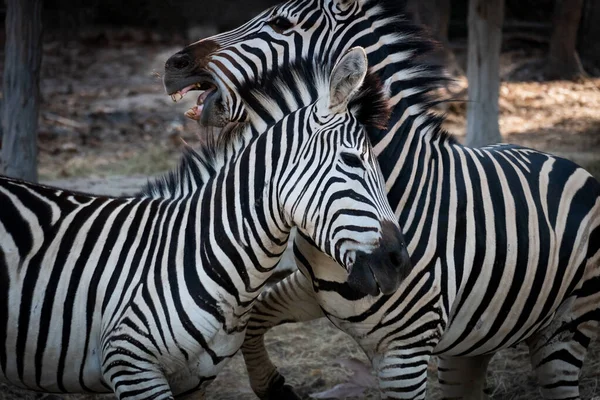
[578,0,600,71]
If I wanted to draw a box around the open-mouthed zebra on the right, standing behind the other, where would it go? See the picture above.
[164,0,600,399]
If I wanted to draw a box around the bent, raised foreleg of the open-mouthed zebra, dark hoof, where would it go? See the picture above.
[242,271,324,399]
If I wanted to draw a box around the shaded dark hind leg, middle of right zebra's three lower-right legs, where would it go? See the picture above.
[438,354,493,400]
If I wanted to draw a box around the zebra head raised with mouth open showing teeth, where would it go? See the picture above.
[164,0,412,127]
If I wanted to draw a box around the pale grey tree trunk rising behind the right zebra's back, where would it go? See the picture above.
[466,0,504,147]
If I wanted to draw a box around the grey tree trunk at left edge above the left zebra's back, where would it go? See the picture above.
[1,0,42,181]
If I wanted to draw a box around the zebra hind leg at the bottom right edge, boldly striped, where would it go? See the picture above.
[527,298,600,400]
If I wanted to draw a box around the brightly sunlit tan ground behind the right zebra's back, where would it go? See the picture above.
[443,78,600,178]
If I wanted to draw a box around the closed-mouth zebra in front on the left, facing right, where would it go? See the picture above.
[0,48,410,399]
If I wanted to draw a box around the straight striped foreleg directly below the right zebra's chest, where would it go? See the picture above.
[373,346,431,400]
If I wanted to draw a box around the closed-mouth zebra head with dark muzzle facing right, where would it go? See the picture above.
[278,47,411,295]
